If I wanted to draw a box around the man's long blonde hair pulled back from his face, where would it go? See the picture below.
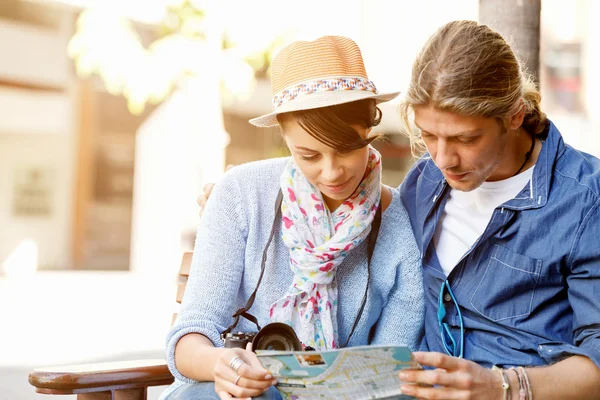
[400,21,547,155]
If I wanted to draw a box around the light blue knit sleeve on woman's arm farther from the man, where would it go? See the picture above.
[166,168,248,383]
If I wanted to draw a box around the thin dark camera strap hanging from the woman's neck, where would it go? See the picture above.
[221,190,381,347]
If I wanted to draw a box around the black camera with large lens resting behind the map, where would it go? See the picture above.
[223,322,302,351]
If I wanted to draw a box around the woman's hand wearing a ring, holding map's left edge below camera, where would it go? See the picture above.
[214,343,277,400]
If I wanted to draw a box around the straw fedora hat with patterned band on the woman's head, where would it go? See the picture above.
[250,36,400,127]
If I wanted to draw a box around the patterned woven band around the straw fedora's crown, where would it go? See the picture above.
[273,77,377,109]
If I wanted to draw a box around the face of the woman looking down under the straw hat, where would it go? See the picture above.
[280,116,370,211]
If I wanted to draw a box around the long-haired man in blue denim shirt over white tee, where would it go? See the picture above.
[200,21,600,399]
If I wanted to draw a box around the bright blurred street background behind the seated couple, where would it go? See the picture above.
[0,0,600,399]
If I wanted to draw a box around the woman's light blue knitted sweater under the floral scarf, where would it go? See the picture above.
[163,158,424,398]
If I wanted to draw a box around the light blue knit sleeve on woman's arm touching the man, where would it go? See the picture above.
[372,233,425,351]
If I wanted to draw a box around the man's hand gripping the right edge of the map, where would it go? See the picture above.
[400,352,504,400]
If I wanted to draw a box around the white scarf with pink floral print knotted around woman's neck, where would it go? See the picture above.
[270,146,381,350]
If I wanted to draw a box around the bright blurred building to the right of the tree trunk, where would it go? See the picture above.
[540,0,600,156]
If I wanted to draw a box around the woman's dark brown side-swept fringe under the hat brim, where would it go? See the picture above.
[277,99,381,152]
